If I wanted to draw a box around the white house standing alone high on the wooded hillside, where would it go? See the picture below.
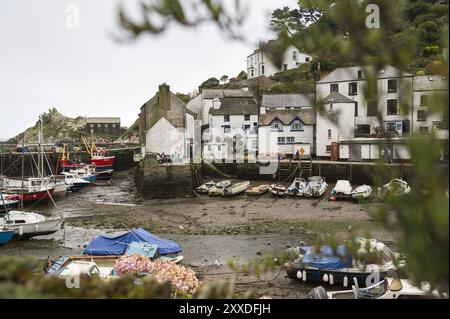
[247,46,312,79]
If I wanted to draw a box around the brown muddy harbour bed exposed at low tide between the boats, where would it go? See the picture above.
[0,171,395,298]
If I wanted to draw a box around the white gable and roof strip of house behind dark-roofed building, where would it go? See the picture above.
[186,89,253,125]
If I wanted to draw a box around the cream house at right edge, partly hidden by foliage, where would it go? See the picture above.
[413,75,448,139]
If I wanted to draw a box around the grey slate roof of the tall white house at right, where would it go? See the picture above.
[317,65,412,84]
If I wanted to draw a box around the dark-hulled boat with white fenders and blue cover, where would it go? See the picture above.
[284,238,404,287]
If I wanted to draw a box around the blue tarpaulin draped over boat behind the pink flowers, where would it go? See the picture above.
[83,228,181,256]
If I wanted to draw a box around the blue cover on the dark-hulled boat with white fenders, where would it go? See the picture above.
[302,245,353,270]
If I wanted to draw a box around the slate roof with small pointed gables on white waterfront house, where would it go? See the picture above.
[258,108,316,126]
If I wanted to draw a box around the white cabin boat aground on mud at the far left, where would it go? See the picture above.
[0,210,64,239]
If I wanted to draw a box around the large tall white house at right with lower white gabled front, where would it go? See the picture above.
[316,66,413,161]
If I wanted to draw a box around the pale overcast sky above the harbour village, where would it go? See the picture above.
[0,0,297,139]
